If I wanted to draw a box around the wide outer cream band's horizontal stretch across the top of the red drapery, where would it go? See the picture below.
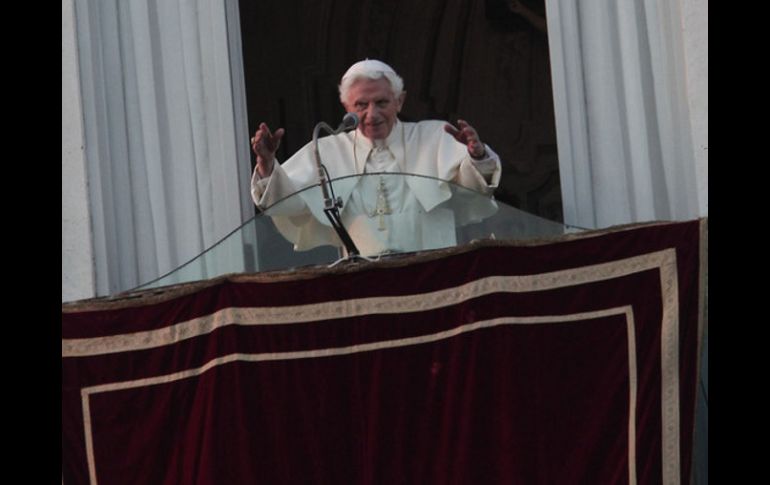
[67,249,676,357]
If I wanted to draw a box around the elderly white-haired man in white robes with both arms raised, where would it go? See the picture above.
[251,60,501,255]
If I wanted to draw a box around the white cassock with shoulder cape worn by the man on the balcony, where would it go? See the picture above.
[251,120,501,256]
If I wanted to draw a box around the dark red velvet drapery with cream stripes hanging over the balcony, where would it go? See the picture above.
[62,221,706,485]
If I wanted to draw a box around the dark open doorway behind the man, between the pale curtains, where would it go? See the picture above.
[240,0,562,221]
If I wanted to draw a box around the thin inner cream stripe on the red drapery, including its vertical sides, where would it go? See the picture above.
[81,306,638,485]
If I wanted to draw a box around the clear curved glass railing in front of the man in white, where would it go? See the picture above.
[132,173,580,291]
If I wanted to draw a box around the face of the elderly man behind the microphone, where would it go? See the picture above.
[342,77,406,140]
